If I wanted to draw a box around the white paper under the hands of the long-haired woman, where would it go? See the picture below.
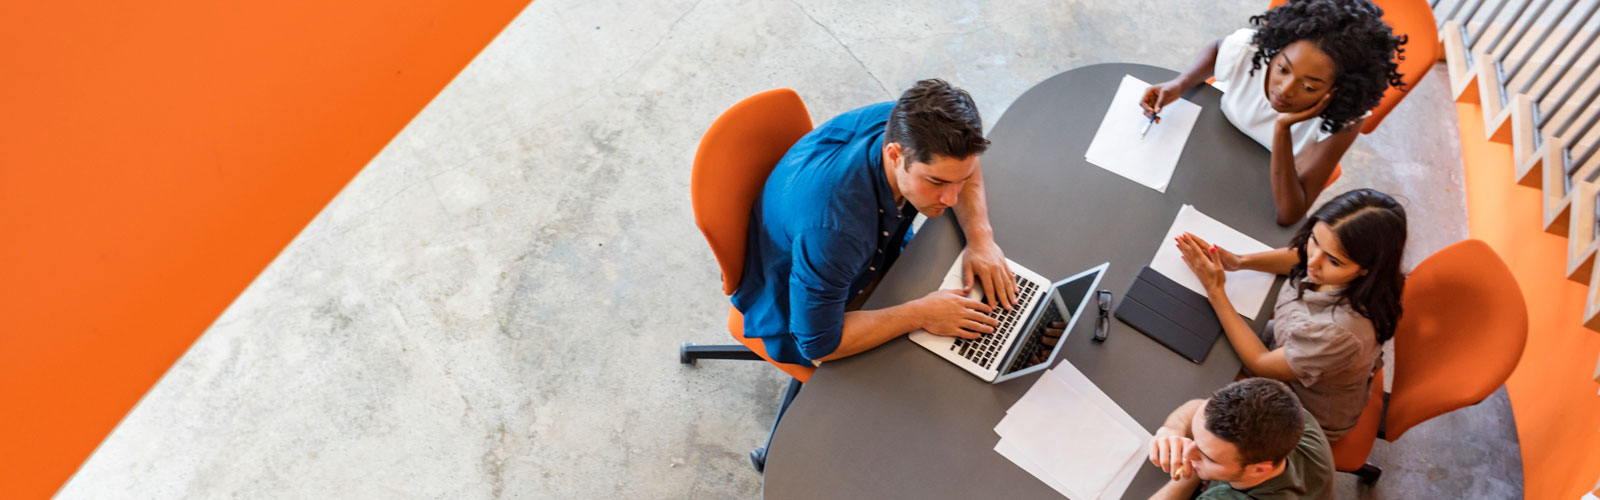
[1150,205,1277,319]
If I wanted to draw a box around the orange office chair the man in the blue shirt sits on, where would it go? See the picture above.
[678,88,816,471]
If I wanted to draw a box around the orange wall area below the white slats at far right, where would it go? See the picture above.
[1456,104,1600,498]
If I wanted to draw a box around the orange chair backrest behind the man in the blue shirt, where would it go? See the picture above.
[690,88,811,295]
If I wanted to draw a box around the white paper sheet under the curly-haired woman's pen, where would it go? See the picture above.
[1083,75,1200,192]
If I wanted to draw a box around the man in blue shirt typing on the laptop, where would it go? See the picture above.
[733,80,1016,365]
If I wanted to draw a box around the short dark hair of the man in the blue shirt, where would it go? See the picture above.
[883,79,989,168]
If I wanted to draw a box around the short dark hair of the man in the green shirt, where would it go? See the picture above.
[1205,378,1306,465]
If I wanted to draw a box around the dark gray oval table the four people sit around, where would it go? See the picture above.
[763,64,1291,498]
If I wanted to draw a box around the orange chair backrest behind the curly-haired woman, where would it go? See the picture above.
[1267,0,1438,133]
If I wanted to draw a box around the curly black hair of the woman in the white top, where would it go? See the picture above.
[1250,0,1406,133]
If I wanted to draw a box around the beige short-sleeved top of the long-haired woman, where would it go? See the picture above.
[1261,280,1384,441]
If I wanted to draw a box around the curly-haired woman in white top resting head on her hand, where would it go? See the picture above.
[1139,0,1406,226]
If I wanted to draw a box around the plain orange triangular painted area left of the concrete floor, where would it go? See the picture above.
[0,0,530,498]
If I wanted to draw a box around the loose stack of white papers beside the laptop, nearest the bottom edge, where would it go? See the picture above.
[995,362,1150,500]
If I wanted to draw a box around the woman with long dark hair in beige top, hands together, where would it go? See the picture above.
[1178,189,1406,441]
